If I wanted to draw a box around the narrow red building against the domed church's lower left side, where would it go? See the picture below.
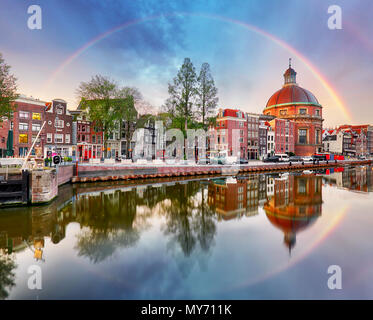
[269,118,295,154]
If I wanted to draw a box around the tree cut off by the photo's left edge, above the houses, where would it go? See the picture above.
[0,53,18,122]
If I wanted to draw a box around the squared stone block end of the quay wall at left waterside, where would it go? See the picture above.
[30,168,58,204]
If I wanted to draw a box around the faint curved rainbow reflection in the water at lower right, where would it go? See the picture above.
[225,207,348,290]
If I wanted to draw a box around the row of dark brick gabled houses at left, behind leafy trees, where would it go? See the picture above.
[0,95,142,160]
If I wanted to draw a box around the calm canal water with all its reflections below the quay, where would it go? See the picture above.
[0,166,373,299]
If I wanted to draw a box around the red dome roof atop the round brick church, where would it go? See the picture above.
[266,84,319,108]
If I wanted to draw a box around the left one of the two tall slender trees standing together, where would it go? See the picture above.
[168,58,197,139]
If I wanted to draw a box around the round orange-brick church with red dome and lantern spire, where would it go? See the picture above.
[263,59,323,156]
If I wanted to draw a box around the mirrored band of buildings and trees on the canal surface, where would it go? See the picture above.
[0,166,373,298]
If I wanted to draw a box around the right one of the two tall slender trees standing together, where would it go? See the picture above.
[197,62,219,129]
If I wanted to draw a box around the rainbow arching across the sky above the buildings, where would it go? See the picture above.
[44,12,351,120]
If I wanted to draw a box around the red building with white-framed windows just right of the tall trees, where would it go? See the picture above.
[214,109,248,159]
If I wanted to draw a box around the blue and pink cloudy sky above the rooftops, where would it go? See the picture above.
[0,0,373,127]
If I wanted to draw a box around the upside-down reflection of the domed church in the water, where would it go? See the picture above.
[264,175,322,250]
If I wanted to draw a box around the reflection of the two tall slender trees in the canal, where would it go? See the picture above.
[161,181,216,275]
